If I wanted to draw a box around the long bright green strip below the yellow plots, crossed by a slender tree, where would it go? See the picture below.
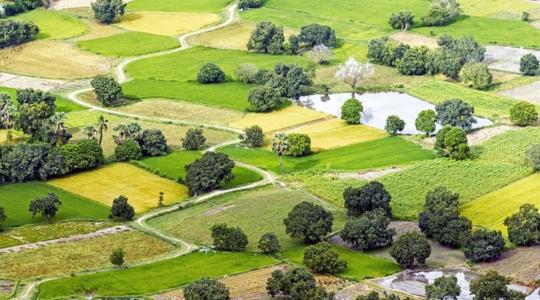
[220,137,435,173]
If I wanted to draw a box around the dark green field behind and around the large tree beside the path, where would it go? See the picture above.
[136,151,262,188]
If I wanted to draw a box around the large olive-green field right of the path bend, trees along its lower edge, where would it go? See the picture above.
[149,186,346,250]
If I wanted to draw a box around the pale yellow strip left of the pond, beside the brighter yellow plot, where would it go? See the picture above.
[229,105,332,132]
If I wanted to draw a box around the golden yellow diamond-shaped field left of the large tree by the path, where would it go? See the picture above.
[49,163,187,213]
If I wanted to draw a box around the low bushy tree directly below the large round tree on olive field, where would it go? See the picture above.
[304,242,347,274]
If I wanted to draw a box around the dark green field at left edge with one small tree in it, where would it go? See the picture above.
[0,182,110,227]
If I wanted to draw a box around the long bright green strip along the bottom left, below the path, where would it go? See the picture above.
[39,252,276,299]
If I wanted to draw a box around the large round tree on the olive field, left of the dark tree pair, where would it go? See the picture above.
[283,201,334,244]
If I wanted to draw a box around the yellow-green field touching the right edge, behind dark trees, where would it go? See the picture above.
[461,174,540,234]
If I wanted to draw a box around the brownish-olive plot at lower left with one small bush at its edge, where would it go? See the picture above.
[0,232,174,280]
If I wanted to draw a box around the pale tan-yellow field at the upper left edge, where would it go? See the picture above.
[0,40,112,79]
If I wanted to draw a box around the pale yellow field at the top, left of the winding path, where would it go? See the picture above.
[116,11,219,35]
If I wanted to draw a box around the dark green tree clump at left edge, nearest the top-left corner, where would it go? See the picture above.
[0,20,39,49]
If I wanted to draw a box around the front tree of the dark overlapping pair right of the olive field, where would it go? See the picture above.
[340,208,396,250]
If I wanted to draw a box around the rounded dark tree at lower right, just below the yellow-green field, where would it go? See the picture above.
[464,229,504,262]
